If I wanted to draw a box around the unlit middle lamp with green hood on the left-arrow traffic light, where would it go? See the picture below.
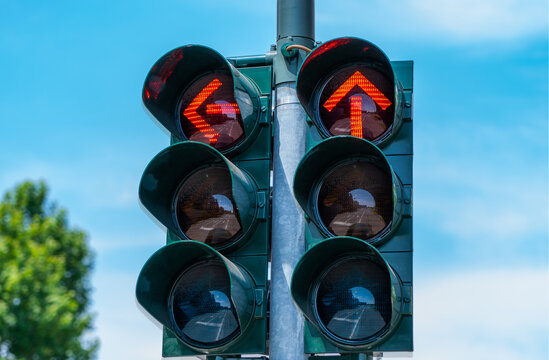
[139,141,267,252]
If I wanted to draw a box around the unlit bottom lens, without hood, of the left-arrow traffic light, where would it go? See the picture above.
[170,261,239,346]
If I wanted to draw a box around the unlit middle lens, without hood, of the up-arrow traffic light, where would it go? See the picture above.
[318,160,393,240]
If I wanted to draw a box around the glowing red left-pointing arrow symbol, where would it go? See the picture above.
[183,78,240,144]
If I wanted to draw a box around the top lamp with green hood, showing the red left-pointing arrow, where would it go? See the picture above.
[143,45,262,156]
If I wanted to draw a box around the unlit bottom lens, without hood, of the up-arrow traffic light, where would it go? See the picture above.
[316,257,392,341]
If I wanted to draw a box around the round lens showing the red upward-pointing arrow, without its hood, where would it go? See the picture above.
[317,65,395,142]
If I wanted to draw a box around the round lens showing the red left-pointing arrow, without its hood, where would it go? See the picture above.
[179,74,244,150]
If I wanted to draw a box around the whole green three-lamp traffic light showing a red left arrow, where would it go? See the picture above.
[136,45,272,357]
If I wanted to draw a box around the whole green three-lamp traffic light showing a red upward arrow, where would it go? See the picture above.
[291,38,413,354]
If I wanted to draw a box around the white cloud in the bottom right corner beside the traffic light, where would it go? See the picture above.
[414,268,549,360]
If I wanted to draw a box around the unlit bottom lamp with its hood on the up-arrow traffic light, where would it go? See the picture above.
[291,237,405,352]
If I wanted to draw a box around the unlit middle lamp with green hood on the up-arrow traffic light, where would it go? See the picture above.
[294,136,404,245]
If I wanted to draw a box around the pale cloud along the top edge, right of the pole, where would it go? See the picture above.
[317,0,547,42]
